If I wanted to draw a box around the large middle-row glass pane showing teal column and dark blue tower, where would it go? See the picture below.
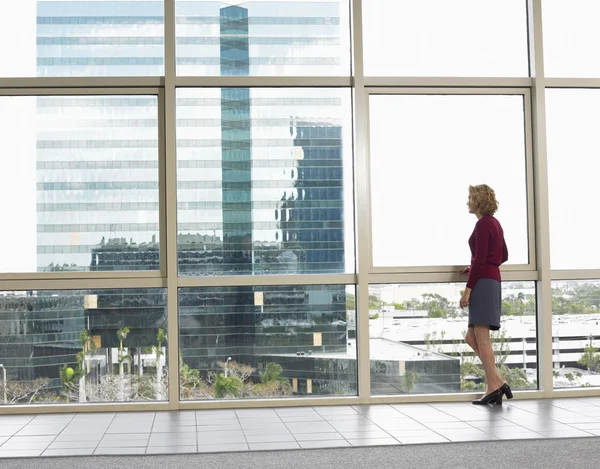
[177,88,354,275]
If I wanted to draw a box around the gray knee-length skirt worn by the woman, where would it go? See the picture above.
[469,278,502,331]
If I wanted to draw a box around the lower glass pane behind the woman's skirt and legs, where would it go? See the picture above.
[370,282,537,395]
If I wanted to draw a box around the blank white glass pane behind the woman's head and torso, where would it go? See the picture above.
[370,95,529,267]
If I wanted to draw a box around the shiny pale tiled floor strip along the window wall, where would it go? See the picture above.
[0,397,600,457]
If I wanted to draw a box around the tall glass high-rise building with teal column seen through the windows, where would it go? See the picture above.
[21,1,352,393]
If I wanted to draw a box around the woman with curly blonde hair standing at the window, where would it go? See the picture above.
[460,184,512,405]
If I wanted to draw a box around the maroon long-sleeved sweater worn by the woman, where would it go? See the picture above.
[467,216,508,288]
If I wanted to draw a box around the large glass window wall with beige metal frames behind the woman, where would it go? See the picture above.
[0,0,600,413]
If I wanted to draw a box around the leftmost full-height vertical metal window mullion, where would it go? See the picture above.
[161,0,179,410]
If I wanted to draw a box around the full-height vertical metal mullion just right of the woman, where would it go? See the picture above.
[527,0,554,397]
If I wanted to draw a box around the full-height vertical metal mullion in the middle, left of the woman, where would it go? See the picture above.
[351,0,371,403]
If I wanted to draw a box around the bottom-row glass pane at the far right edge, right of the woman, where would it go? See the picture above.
[552,280,600,388]
